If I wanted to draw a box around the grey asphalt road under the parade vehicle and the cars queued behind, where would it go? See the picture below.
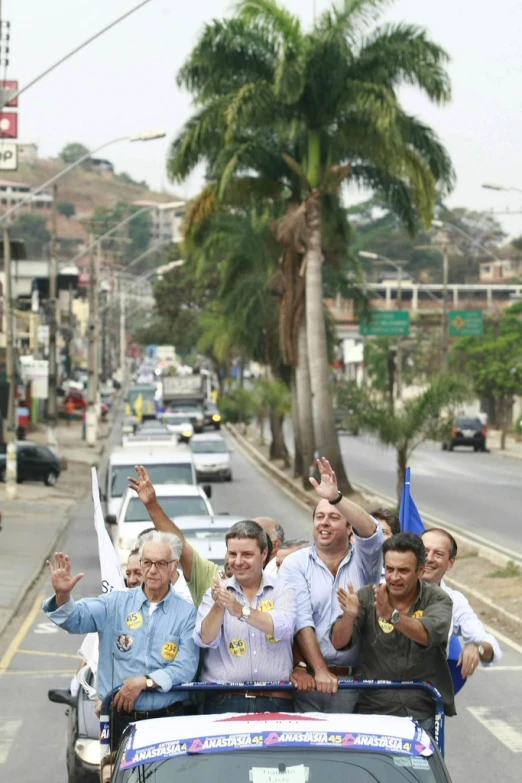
[0,432,522,783]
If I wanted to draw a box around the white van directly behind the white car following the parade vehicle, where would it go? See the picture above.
[102,444,197,525]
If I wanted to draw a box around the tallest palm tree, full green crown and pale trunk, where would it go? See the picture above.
[170,0,453,491]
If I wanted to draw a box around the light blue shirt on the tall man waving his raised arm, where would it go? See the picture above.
[278,525,384,666]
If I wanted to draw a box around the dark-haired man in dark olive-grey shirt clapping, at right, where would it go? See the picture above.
[331,533,455,733]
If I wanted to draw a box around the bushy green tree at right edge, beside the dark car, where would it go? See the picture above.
[451,303,522,449]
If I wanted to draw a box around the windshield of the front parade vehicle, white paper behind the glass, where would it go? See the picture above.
[116,752,434,783]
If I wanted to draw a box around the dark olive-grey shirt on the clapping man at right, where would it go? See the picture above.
[340,581,456,720]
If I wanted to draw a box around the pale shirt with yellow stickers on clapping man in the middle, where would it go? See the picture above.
[194,573,295,682]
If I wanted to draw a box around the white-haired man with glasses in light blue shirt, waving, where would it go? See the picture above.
[43,531,199,738]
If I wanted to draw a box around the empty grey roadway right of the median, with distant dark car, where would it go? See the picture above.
[341,435,522,555]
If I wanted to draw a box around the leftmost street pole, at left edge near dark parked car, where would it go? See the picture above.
[4,228,18,500]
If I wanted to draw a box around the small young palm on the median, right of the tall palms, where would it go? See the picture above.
[359,375,470,504]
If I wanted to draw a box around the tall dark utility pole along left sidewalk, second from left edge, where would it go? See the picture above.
[47,180,58,446]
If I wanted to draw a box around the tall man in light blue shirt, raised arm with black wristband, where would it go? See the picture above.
[279,458,384,712]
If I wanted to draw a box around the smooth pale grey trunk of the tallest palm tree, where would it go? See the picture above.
[305,190,353,494]
